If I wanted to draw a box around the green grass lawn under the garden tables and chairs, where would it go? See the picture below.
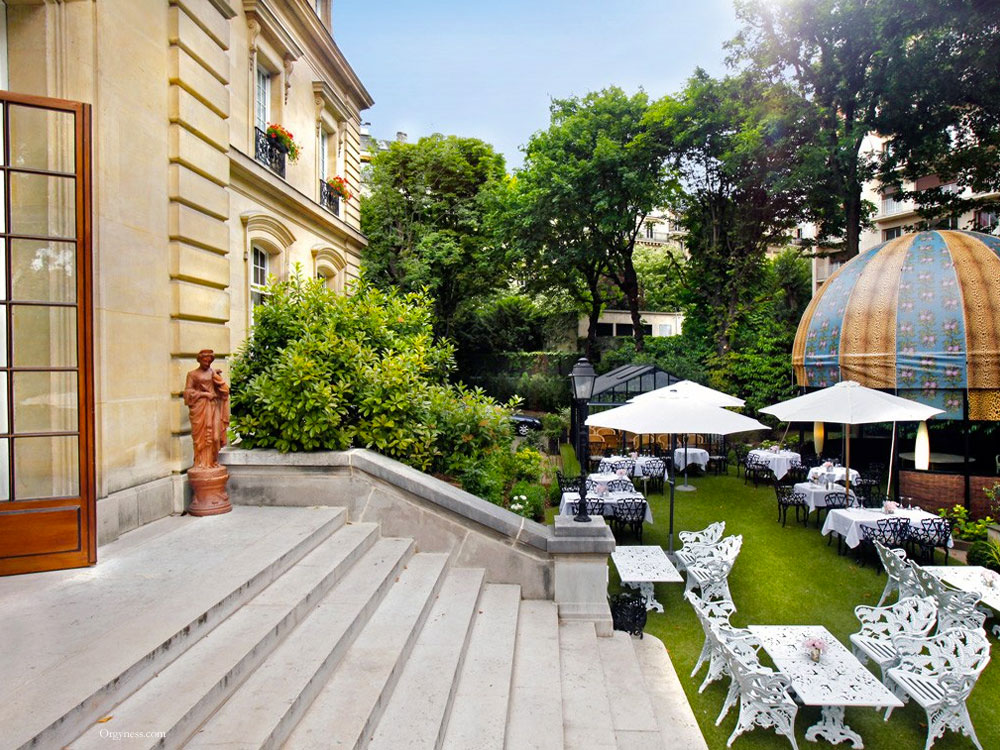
[550,451,1000,750]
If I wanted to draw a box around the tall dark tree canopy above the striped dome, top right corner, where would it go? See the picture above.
[730,0,1000,258]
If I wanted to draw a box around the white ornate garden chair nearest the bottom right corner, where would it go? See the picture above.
[885,629,990,750]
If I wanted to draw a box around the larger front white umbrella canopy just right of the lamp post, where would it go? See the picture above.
[587,392,769,435]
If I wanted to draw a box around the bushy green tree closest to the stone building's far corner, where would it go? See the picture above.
[361,135,509,335]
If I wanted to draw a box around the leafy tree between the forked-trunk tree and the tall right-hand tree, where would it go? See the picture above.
[651,70,808,359]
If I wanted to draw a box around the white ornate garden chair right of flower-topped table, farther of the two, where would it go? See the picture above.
[850,597,938,682]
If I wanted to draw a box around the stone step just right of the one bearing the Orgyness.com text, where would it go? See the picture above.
[185,539,413,749]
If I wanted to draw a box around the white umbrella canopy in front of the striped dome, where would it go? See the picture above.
[761,380,943,424]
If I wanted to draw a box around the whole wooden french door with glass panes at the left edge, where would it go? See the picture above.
[0,91,97,575]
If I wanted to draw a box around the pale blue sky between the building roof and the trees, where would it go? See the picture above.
[333,0,737,168]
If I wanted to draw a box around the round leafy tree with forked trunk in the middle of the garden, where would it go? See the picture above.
[503,87,674,354]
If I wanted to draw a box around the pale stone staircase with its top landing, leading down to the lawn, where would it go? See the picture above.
[0,506,705,750]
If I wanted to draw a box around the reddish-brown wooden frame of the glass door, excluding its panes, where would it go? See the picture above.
[0,91,97,575]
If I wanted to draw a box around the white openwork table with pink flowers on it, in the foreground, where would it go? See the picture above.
[749,625,903,750]
